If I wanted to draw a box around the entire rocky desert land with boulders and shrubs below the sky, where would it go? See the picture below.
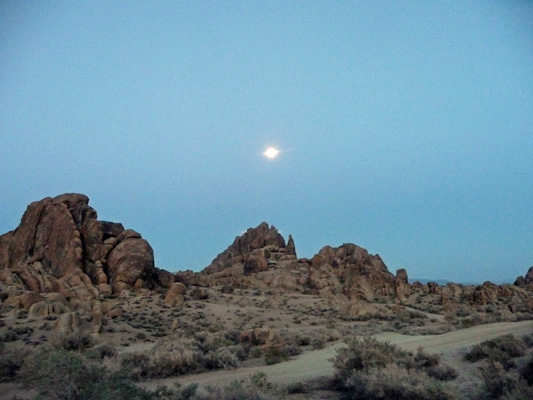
[0,205,533,400]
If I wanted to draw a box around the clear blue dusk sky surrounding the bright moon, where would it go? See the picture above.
[0,0,533,282]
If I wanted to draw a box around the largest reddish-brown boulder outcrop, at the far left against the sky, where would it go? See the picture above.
[0,193,163,300]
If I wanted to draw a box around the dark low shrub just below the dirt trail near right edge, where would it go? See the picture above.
[464,335,526,368]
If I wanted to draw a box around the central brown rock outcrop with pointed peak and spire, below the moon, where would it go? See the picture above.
[188,223,404,300]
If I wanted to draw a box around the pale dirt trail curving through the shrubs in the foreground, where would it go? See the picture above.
[143,321,533,389]
